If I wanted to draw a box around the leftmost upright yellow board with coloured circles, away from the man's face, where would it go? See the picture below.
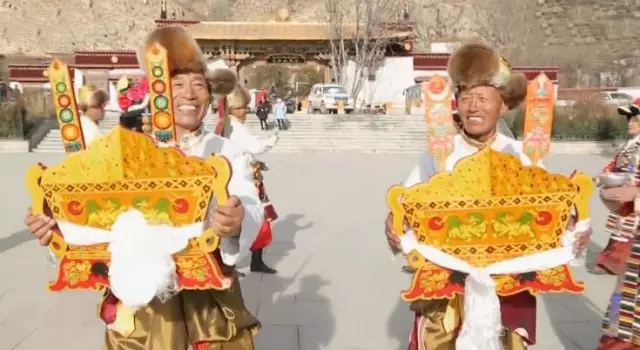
[47,59,86,152]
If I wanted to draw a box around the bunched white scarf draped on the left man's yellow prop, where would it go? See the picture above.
[58,209,203,310]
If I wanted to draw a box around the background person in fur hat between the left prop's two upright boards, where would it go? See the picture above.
[78,84,109,145]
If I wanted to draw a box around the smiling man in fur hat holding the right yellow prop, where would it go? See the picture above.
[385,44,589,350]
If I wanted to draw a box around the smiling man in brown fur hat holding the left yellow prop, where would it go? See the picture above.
[25,26,263,350]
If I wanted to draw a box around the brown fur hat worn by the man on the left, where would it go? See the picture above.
[138,26,238,95]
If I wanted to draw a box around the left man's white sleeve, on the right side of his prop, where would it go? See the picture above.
[220,154,263,266]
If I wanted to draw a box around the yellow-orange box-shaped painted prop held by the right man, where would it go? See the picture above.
[387,148,593,301]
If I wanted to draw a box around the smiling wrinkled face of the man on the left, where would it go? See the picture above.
[171,73,210,131]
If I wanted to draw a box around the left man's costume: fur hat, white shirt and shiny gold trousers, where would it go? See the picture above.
[101,27,262,350]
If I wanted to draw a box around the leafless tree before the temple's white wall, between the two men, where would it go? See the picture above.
[325,0,401,99]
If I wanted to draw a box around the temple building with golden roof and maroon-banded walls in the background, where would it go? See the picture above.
[8,13,558,110]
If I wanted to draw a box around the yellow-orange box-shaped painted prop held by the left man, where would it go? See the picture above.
[26,126,231,291]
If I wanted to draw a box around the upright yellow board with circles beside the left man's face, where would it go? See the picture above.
[144,43,176,143]
